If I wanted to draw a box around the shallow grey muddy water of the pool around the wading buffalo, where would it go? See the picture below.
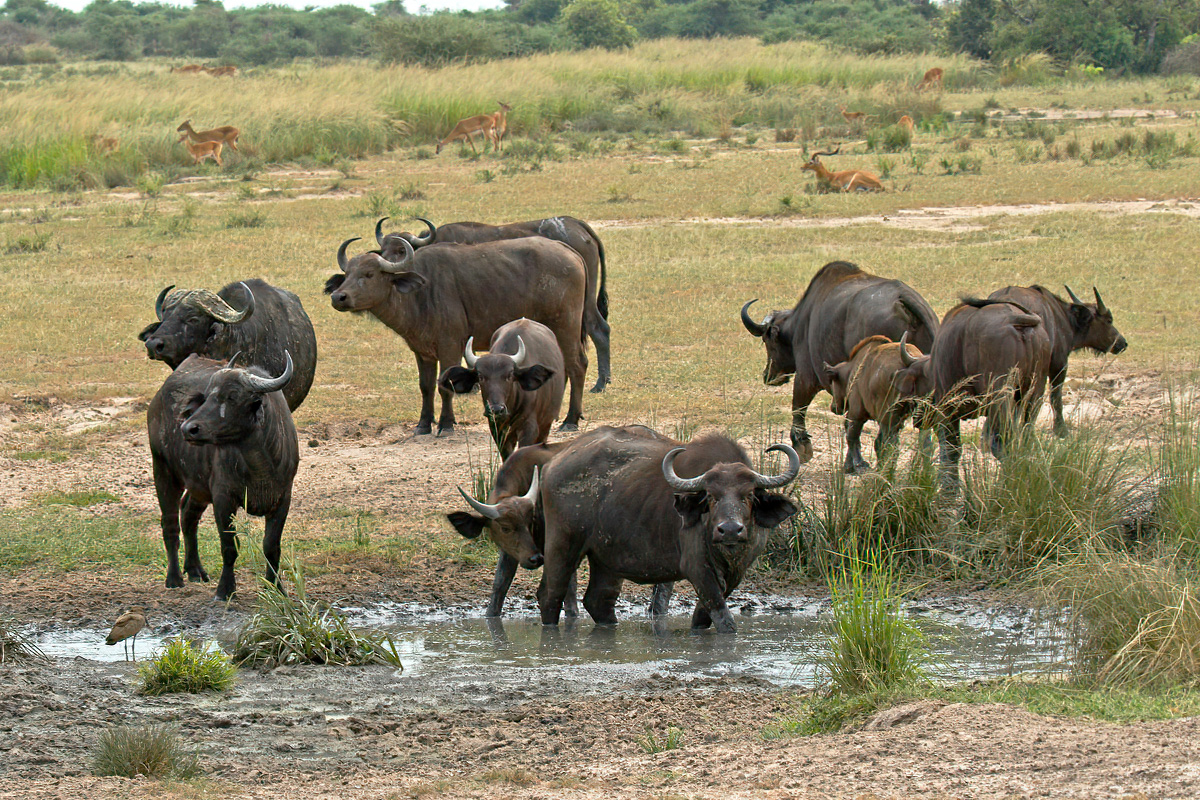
[30,596,1066,702]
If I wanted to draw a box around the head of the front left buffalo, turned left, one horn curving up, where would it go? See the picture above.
[179,350,293,445]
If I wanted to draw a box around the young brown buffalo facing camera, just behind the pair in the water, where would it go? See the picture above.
[438,319,566,458]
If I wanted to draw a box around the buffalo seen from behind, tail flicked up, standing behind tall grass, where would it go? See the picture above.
[895,299,1050,491]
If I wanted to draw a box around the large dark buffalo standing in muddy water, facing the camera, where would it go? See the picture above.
[538,427,800,633]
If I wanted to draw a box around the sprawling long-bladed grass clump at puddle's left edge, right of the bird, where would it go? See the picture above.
[233,570,401,668]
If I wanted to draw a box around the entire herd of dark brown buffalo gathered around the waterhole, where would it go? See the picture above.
[139,217,1127,633]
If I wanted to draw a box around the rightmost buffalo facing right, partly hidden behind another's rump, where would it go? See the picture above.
[988,285,1129,437]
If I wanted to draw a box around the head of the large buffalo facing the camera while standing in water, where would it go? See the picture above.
[662,444,800,547]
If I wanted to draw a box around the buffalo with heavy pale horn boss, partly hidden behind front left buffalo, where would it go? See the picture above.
[138,278,317,411]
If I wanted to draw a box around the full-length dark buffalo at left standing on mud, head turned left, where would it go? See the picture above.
[146,353,300,600]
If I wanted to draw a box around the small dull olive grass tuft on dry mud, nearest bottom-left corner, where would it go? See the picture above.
[91,724,199,781]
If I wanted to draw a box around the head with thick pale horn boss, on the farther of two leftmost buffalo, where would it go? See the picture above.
[138,283,254,369]
